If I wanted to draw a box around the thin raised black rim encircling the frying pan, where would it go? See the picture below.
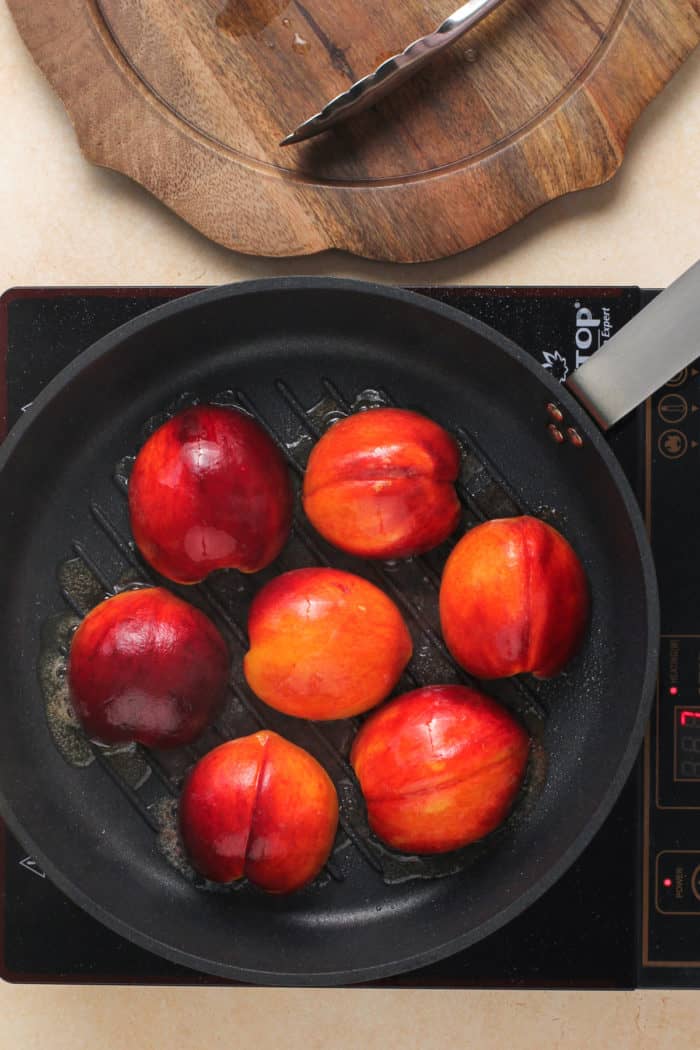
[0,277,660,987]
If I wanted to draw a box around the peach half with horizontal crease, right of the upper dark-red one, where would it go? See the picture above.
[302,408,461,559]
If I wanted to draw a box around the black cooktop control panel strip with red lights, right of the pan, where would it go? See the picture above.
[641,350,700,985]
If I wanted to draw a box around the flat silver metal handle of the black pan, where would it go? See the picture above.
[566,259,700,431]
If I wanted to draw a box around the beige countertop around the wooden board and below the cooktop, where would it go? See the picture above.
[0,4,700,1050]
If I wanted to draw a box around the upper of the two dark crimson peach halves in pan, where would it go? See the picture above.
[129,405,292,584]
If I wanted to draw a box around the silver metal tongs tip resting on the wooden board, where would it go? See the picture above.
[280,0,504,146]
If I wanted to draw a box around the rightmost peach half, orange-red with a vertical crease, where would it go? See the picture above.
[440,517,590,678]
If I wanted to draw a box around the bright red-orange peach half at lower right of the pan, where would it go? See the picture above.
[351,686,530,854]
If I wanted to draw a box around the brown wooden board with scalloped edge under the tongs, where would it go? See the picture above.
[8,0,700,261]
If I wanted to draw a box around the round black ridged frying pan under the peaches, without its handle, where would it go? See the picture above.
[0,278,658,985]
